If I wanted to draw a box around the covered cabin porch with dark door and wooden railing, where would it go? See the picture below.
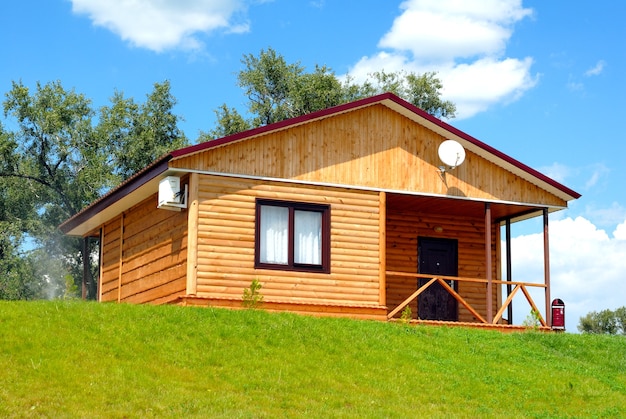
[381,193,551,330]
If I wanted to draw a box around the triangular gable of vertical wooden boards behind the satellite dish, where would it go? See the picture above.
[170,105,567,207]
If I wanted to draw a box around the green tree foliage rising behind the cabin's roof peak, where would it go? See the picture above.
[199,48,456,142]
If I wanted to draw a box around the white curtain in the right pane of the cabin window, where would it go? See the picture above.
[293,211,322,265]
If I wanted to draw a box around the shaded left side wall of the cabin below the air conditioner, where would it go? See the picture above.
[100,189,187,304]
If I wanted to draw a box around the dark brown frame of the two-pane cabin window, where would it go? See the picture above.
[254,198,330,273]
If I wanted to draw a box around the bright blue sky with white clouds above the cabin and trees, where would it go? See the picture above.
[0,0,626,331]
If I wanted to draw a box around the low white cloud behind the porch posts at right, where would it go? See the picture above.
[504,217,626,332]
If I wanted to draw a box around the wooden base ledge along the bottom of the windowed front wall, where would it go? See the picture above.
[172,295,387,321]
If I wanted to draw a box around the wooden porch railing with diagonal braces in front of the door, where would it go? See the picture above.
[386,271,548,327]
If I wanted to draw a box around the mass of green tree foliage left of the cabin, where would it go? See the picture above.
[0,81,187,299]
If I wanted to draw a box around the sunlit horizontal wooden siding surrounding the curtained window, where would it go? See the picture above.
[196,175,380,306]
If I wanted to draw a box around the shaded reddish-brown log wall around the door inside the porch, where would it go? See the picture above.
[387,211,500,322]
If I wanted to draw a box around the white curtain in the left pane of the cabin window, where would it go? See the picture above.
[260,205,289,265]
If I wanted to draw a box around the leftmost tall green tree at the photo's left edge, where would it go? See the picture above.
[0,81,106,298]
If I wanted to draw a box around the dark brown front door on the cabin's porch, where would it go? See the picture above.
[417,237,458,321]
